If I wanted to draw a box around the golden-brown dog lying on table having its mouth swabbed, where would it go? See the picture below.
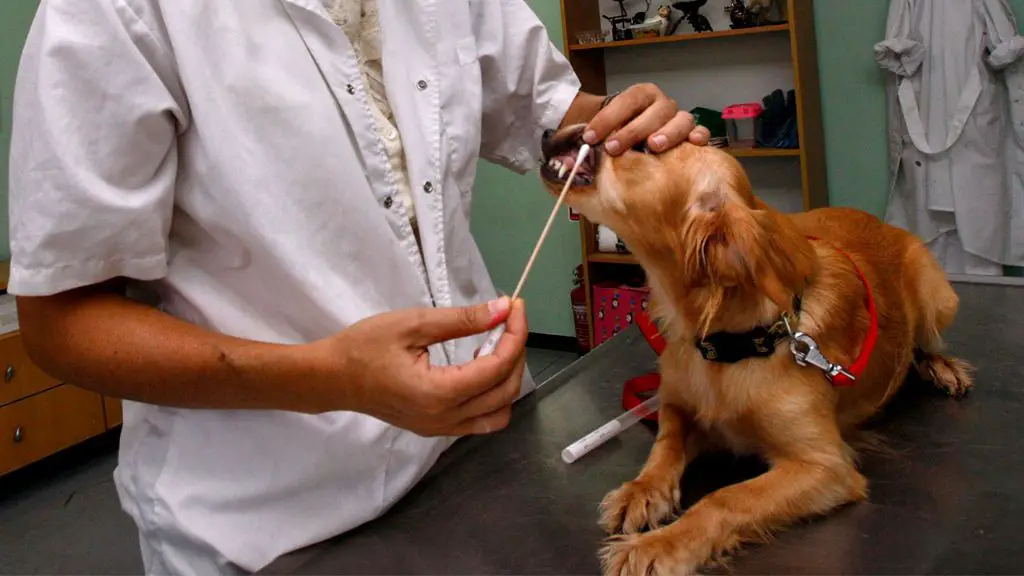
[541,126,972,576]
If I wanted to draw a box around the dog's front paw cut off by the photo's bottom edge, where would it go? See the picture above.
[601,530,697,576]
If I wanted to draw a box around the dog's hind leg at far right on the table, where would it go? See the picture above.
[914,255,974,398]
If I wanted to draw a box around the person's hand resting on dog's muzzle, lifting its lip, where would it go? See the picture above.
[583,84,711,156]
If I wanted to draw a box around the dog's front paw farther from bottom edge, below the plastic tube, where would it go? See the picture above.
[601,478,680,534]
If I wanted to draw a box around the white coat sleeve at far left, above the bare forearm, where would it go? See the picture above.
[8,0,186,295]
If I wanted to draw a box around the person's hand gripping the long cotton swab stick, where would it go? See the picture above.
[310,298,527,437]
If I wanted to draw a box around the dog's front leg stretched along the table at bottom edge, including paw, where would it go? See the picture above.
[602,448,867,576]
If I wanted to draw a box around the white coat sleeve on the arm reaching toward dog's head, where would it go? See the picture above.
[473,0,580,173]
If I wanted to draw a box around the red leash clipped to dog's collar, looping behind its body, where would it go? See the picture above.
[623,236,879,414]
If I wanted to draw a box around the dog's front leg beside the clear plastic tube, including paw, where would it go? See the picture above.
[600,404,701,534]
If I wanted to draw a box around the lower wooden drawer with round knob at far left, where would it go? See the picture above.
[0,384,106,475]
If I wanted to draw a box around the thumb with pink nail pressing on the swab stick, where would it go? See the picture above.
[410,297,510,346]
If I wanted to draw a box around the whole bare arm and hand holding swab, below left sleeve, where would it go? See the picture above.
[17,283,526,436]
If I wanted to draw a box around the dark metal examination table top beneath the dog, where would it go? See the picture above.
[264,284,1024,575]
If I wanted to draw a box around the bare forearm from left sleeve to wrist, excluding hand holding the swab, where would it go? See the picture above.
[17,282,316,412]
